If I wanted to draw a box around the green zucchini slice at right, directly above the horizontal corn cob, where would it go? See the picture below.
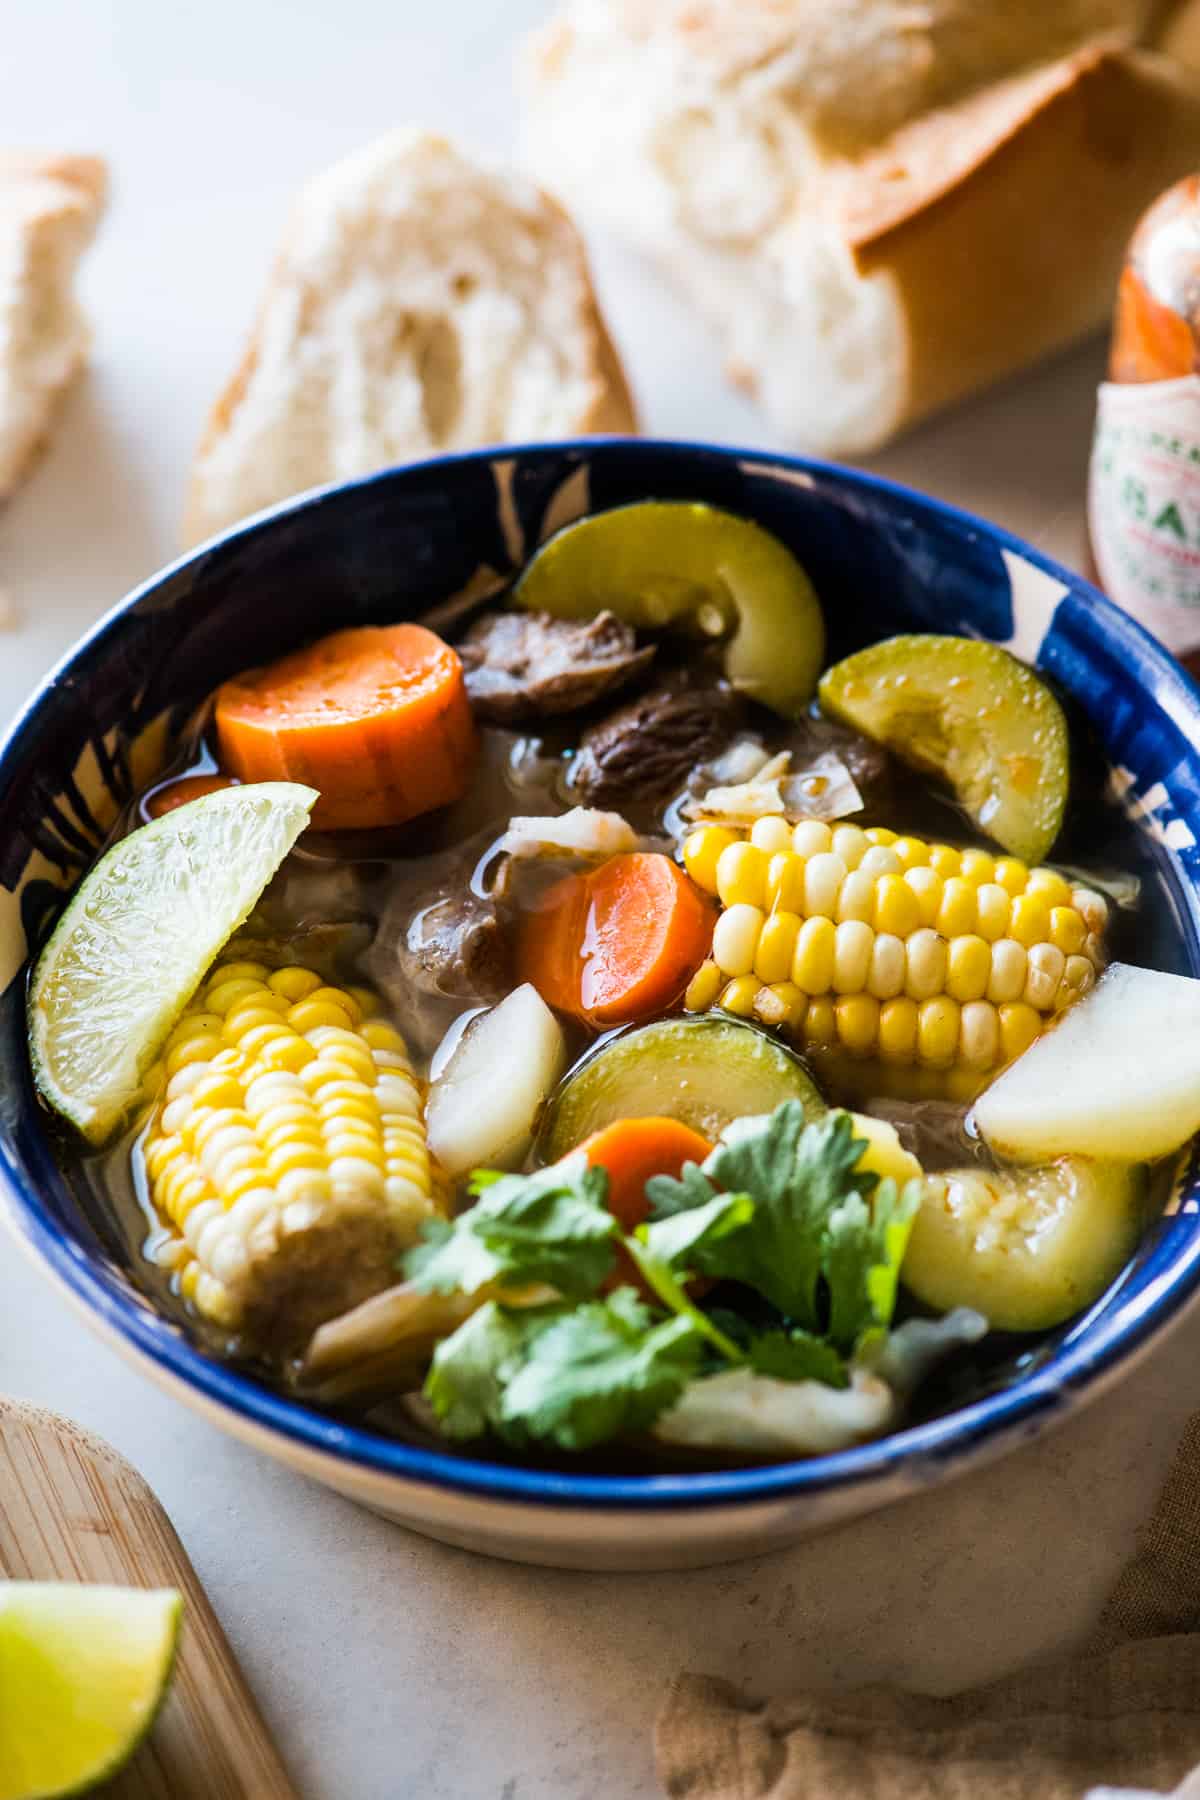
[819,634,1070,862]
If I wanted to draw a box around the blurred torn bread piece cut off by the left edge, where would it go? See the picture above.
[0,151,108,499]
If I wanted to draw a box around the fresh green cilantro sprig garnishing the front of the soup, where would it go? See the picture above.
[405,1100,921,1451]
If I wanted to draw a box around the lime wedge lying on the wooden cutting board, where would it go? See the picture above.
[0,1580,184,1800]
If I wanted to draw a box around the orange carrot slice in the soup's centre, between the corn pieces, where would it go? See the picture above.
[518,850,714,1026]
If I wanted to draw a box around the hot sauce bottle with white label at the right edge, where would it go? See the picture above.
[1088,175,1200,673]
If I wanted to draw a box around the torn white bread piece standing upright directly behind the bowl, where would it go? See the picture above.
[184,128,635,544]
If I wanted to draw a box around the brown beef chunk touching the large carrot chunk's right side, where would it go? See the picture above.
[457,612,655,725]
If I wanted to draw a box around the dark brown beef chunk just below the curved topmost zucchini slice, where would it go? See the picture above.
[570,679,743,808]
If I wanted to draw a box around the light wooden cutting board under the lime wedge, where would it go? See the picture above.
[0,1399,299,1800]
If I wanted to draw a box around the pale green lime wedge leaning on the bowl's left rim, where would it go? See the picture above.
[29,781,317,1143]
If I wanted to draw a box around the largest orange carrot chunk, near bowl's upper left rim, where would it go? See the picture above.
[216,625,475,832]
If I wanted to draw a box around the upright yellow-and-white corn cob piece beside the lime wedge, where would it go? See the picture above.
[144,961,435,1346]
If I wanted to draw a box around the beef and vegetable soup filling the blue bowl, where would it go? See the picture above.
[29,502,1200,1462]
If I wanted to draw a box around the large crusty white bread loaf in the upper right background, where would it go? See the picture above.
[524,0,1200,454]
